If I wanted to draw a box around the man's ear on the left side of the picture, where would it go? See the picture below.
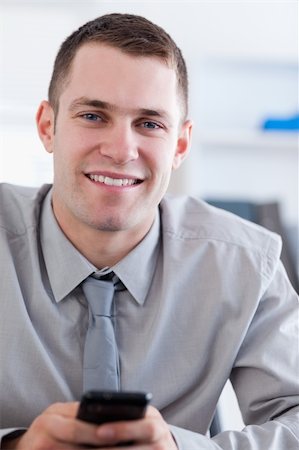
[36,100,55,153]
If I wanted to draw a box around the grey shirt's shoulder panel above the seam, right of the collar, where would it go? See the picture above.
[160,194,281,276]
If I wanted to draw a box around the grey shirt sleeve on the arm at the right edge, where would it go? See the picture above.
[171,263,299,450]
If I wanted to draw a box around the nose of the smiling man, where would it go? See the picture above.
[101,122,138,165]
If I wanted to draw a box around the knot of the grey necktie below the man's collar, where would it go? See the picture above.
[82,276,114,317]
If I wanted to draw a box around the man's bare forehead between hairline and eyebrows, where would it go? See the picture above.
[61,43,179,118]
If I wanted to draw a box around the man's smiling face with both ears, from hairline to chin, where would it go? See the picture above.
[37,44,191,241]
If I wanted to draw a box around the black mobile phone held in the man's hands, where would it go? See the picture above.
[77,391,152,425]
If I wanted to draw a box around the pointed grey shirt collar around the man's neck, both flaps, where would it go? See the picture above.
[40,186,160,305]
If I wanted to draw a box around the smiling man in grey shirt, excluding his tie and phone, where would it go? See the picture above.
[0,14,299,450]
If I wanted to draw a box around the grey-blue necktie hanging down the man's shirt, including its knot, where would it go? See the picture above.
[82,276,119,391]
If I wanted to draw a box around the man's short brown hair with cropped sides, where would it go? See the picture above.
[48,13,188,118]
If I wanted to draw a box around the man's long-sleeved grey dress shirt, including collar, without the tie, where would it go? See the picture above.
[0,184,299,450]
